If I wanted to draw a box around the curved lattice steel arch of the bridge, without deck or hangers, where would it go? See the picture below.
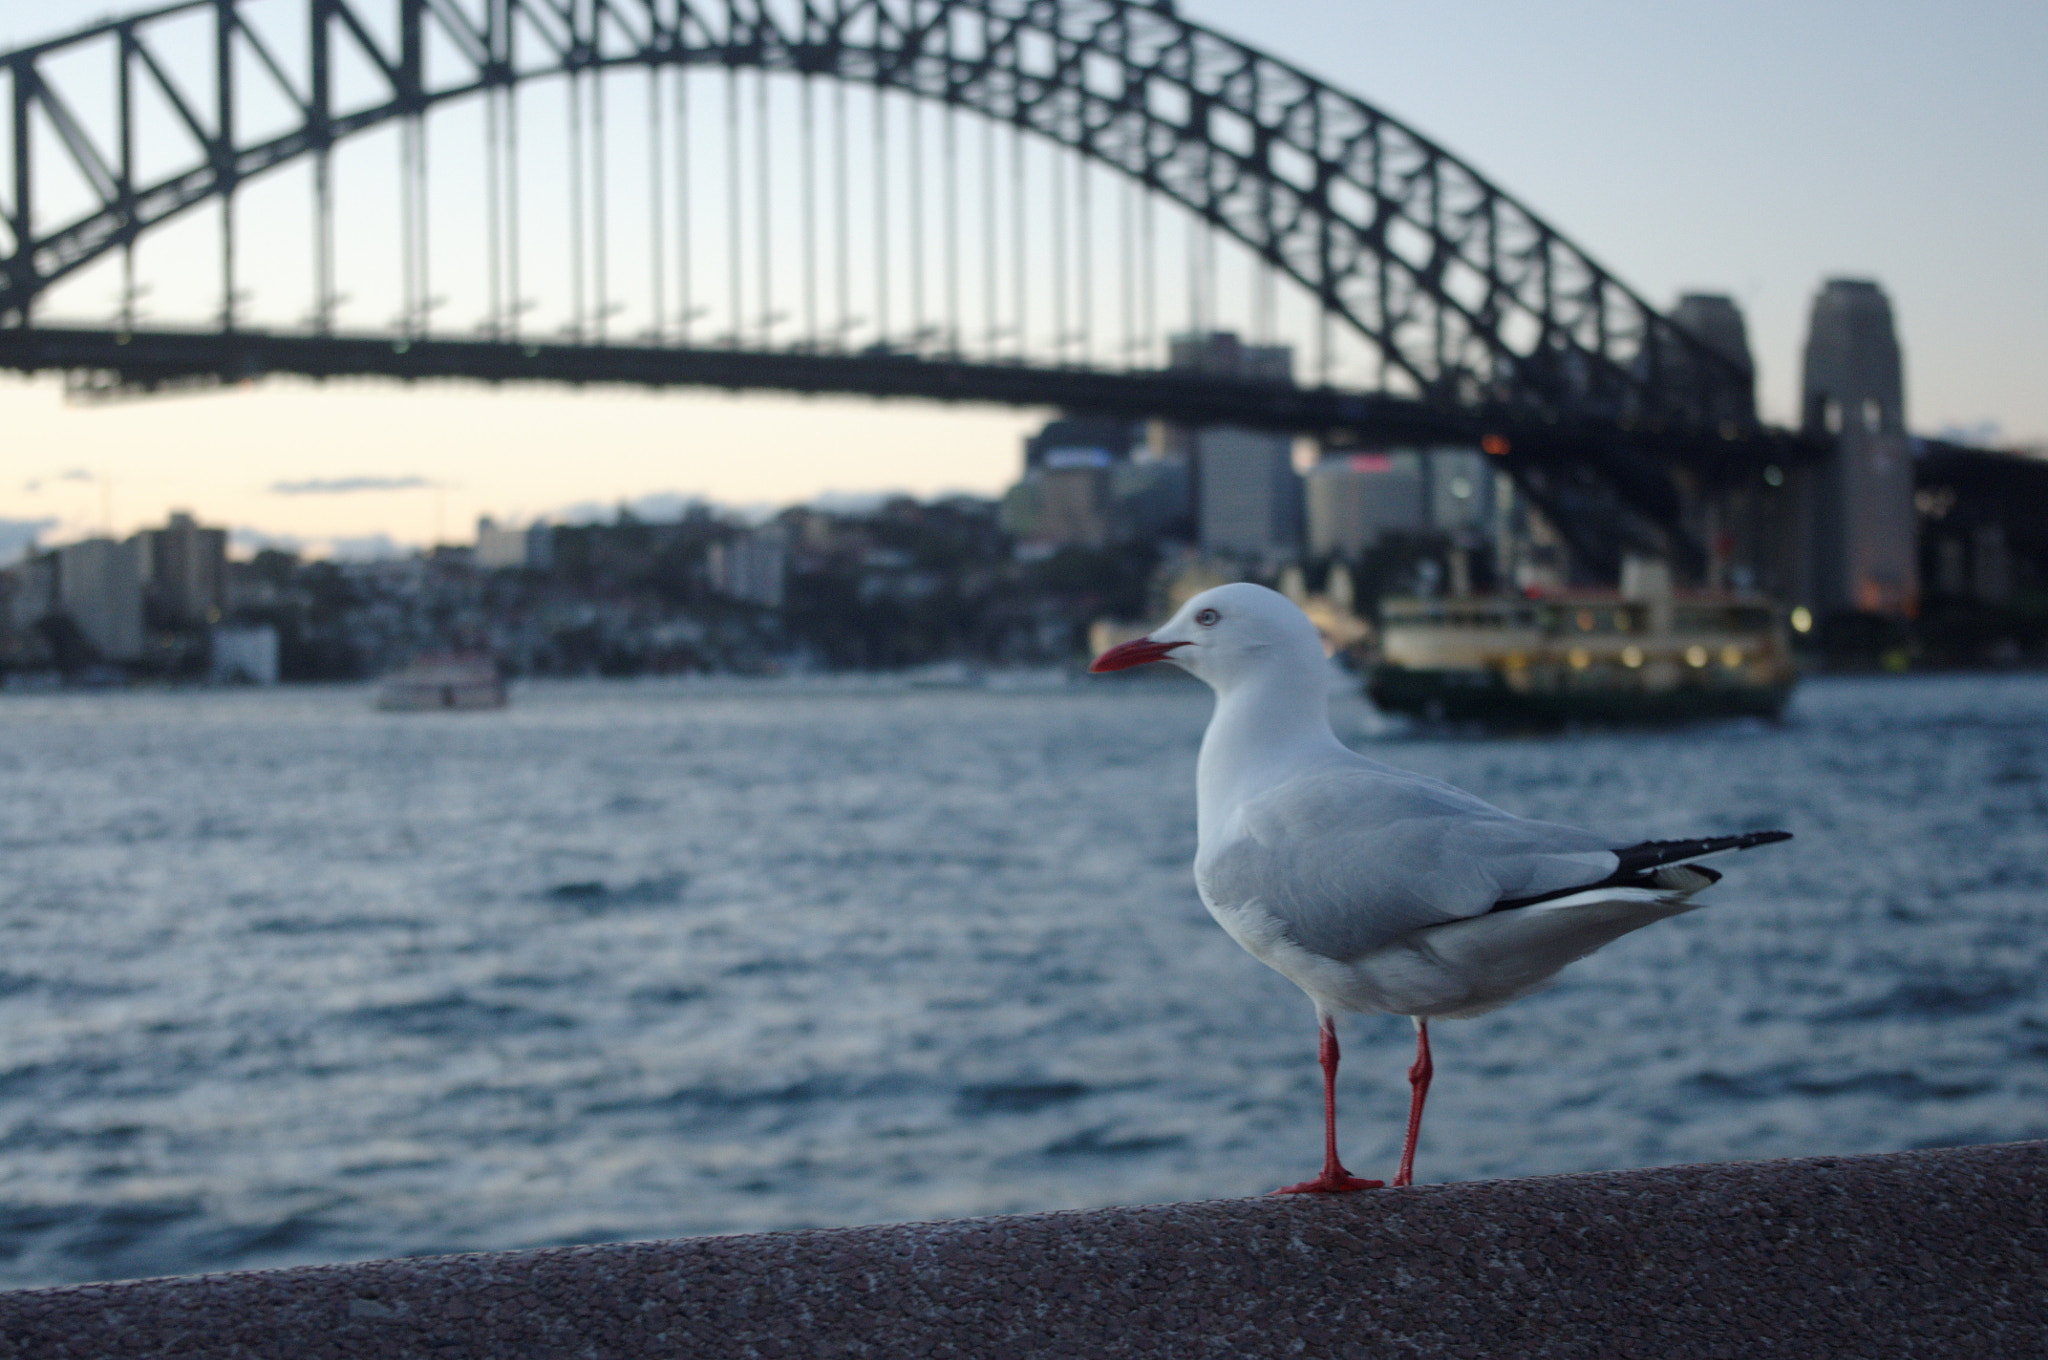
[0,0,1753,434]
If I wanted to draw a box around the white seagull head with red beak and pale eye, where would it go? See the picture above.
[1087,582,1323,694]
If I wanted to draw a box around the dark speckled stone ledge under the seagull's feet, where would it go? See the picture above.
[0,1143,2048,1360]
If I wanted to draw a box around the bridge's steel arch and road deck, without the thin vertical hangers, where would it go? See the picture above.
[0,0,1815,569]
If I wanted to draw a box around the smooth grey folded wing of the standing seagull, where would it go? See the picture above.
[1196,762,1618,959]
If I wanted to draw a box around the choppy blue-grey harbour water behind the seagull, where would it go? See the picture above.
[0,678,2048,1284]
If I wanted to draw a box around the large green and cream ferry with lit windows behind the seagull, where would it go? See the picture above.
[1366,588,1798,727]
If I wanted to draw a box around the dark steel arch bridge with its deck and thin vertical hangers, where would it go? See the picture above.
[0,0,1802,559]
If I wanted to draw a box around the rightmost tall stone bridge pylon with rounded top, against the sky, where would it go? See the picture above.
[1800,279,1919,614]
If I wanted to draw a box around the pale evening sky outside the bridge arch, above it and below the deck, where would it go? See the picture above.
[0,0,2048,561]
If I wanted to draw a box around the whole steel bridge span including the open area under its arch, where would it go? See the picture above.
[0,0,1802,559]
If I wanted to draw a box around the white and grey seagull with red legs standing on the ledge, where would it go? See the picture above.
[1090,582,1790,1194]
